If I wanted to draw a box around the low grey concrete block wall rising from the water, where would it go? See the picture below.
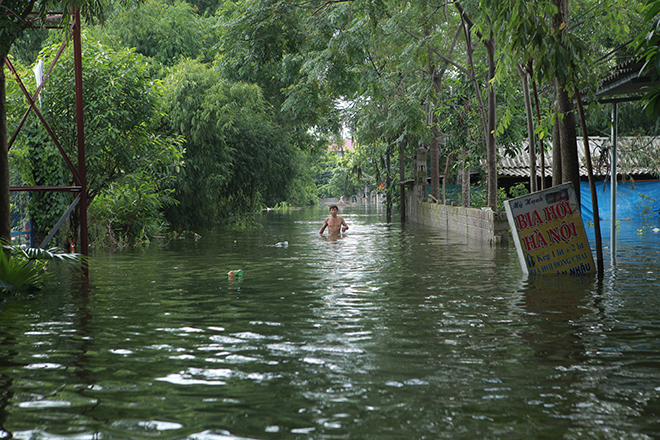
[407,197,510,244]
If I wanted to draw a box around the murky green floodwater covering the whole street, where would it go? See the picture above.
[0,207,660,440]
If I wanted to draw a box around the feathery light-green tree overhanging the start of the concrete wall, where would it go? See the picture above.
[287,0,454,216]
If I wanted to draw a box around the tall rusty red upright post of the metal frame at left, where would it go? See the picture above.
[72,8,89,268]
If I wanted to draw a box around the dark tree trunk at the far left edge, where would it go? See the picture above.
[0,54,11,244]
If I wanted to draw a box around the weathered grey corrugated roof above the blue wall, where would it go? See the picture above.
[497,137,660,178]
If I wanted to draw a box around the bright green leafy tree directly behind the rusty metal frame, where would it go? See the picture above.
[9,38,181,246]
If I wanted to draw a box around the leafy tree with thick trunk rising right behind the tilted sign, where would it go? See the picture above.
[500,0,639,192]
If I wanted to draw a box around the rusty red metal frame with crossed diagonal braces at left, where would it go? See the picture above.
[5,8,89,256]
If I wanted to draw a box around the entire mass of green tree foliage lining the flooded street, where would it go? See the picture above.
[0,0,660,248]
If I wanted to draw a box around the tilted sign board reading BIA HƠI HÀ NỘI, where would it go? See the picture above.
[504,183,596,275]
